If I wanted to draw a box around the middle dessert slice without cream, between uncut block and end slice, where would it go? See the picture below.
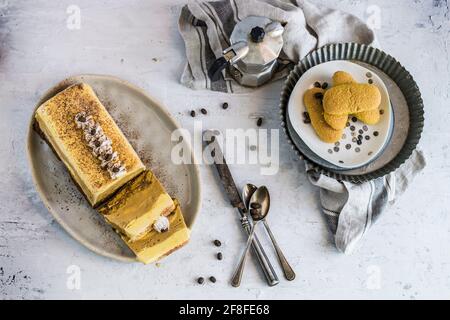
[98,170,175,241]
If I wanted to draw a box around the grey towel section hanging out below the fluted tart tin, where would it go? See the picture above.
[306,150,426,254]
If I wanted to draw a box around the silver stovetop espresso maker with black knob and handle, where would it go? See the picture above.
[208,16,284,87]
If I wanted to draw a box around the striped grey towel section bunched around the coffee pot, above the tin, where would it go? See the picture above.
[179,0,375,93]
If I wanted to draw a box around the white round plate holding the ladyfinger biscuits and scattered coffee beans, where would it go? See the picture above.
[288,60,394,169]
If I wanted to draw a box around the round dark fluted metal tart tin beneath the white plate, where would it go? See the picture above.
[280,43,424,183]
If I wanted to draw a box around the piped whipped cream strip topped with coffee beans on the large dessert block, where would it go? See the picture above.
[75,112,127,179]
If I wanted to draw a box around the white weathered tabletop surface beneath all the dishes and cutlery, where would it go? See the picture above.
[0,0,450,299]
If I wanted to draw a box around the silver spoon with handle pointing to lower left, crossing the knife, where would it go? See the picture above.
[231,187,270,287]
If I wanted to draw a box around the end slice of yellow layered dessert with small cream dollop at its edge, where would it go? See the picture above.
[123,200,190,264]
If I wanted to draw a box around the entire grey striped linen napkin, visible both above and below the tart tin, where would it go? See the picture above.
[179,0,425,254]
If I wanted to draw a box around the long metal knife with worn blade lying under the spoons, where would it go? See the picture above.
[204,130,279,286]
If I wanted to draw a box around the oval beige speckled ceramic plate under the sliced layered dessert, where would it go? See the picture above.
[27,75,201,261]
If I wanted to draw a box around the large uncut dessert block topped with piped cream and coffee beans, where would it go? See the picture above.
[35,83,144,206]
